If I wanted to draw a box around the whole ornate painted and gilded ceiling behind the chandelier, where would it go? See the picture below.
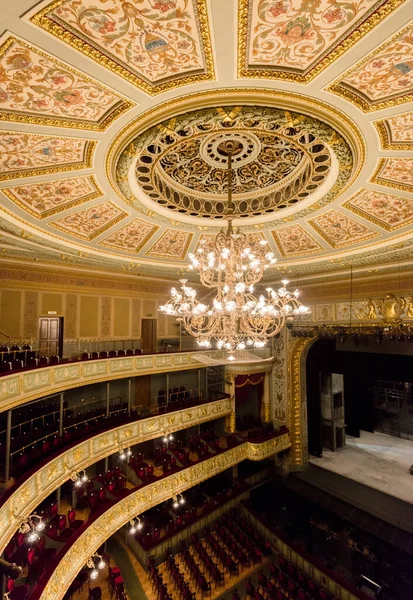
[0,0,413,280]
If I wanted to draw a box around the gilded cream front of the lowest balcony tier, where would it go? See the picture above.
[36,434,291,600]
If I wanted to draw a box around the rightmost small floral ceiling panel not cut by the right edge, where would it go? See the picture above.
[309,210,379,248]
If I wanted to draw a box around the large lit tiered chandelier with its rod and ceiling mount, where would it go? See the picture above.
[159,140,309,358]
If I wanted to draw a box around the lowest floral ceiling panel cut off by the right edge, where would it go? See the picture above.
[343,189,413,231]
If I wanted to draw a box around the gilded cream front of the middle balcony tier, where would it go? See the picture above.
[0,398,231,550]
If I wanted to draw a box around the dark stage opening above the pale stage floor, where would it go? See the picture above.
[306,334,413,456]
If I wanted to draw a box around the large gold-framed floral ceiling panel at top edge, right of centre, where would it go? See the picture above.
[239,0,396,82]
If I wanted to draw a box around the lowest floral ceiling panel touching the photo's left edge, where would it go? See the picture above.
[2,175,103,219]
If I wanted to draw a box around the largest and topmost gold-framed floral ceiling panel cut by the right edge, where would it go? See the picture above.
[329,22,413,112]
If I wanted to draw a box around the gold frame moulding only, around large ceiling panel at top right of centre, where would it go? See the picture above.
[237,0,405,84]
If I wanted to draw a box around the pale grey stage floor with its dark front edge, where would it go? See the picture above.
[296,431,413,533]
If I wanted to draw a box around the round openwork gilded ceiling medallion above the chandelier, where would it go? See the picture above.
[116,105,353,225]
